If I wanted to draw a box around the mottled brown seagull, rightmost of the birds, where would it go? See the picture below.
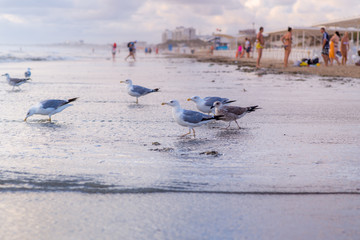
[212,101,259,129]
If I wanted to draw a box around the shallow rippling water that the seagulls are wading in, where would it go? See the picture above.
[0,46,360,239]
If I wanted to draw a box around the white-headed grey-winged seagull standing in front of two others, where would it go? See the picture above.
[161,100,222,137]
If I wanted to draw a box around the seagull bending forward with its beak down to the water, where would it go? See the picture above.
[24,98,77,122]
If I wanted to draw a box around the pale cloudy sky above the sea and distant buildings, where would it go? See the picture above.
[0,0,360,44]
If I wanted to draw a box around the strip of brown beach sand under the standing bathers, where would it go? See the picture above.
[168,53,360,79]
